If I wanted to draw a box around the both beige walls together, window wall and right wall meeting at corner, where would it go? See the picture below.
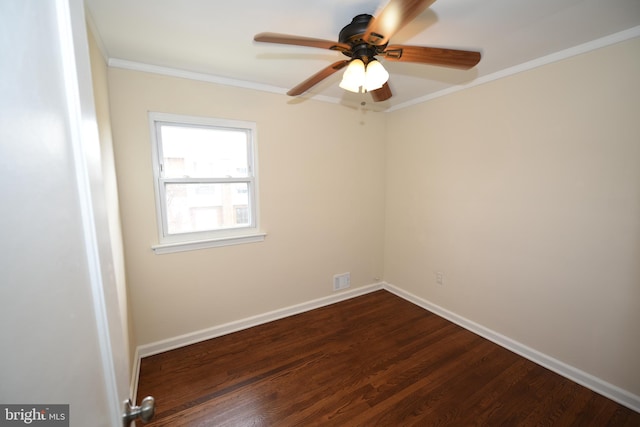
[109,39,640,395]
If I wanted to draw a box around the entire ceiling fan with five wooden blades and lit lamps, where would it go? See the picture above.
[254,0,481,102]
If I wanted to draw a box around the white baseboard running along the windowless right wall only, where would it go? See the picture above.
[384,283,640,412]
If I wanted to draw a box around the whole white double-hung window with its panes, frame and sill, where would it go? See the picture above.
[149,113,264,253]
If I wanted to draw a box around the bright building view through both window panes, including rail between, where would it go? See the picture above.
[159,123,251,234]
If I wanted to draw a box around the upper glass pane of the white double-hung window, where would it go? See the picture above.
[160,124,249,178]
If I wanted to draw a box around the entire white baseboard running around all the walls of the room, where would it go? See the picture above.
[131,282,640,412]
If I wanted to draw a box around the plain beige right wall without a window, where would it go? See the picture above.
[384,39,640,395]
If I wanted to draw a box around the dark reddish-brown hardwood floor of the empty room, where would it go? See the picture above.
[138,291,640,426]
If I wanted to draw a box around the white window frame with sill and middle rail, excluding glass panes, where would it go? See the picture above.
[149,112,266,254]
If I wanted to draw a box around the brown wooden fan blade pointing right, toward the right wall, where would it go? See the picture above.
[382,45,481,70]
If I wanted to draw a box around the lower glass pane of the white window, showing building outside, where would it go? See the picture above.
[165,182,251,234]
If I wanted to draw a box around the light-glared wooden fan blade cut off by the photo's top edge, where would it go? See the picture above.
[363,0,435,46]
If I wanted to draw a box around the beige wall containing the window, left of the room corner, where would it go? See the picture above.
[109,68,385,345]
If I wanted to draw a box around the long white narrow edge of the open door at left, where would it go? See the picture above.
[56,0,131,426]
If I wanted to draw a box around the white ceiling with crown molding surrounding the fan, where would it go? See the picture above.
[86,0,640,110]
